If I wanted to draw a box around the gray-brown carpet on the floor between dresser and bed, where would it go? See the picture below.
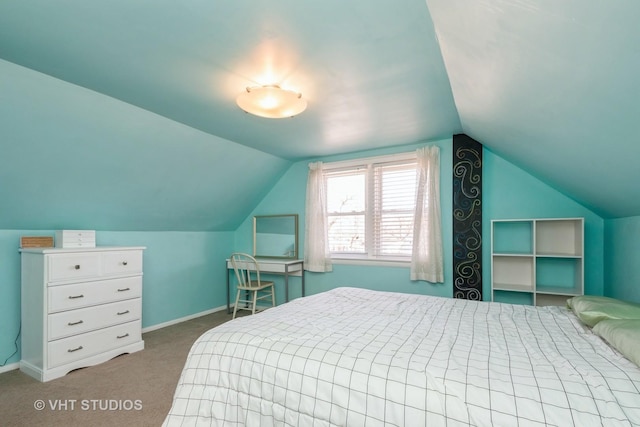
[0,311,239,427]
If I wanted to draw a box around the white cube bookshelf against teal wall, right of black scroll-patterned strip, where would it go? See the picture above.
[491,218,584,305]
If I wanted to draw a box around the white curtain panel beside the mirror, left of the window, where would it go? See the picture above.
[304,162,332,272]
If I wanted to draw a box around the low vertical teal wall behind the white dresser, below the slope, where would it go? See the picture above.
[0,230,233,363]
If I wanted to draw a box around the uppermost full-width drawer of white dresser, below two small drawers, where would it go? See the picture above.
[47,276,142,313]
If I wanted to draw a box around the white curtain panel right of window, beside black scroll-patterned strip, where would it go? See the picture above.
[411,146,444,283]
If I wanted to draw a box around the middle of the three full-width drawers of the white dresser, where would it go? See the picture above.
[48,298,142,341]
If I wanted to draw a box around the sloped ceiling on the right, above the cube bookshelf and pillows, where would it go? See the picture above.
[427,0,640,217]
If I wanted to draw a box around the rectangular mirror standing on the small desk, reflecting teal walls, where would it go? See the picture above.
[253,214,298,259]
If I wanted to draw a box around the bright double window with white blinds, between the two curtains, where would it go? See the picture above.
[324,153,417,262]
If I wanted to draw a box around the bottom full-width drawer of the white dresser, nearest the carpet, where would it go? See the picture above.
[47,320,142,368]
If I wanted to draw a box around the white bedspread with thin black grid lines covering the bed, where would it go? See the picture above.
[164,287,640,427]
